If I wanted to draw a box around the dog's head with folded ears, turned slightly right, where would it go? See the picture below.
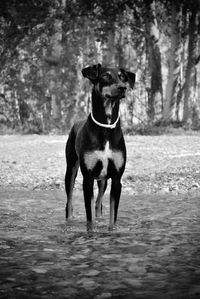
[82,64,135,100]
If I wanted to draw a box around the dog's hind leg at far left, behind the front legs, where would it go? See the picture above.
[65,131,79,218]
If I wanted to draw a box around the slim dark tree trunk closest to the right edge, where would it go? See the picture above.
[183,7,197,126]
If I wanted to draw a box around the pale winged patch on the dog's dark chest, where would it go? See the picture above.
[84,142,124,178]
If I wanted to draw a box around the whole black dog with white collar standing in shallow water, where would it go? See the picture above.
[65,64,135,231]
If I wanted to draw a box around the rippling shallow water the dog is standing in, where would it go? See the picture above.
[0,189,200,299]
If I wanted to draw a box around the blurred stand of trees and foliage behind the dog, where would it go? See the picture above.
[0,0,200,134]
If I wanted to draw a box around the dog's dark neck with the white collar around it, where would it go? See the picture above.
[91,89,119,129]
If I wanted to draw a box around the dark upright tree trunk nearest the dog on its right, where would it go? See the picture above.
[145,1,163,123]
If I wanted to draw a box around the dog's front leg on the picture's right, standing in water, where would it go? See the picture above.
[109,178,122,230]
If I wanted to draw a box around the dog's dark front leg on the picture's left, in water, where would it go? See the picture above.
[83,178,95,232]
